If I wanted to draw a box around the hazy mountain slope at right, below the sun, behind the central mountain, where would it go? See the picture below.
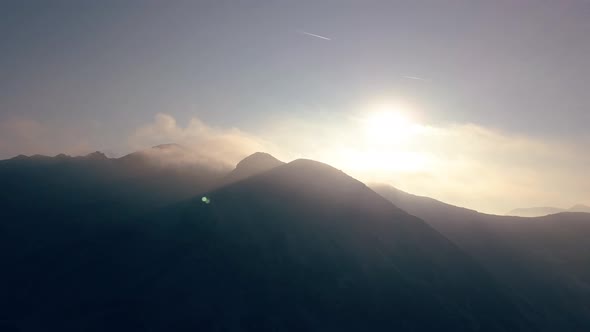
[371,185,590,331]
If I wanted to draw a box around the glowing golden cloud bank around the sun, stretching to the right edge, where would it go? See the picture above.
[254,113,590,213]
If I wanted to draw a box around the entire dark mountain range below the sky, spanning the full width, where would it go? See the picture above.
[0,144,590,331]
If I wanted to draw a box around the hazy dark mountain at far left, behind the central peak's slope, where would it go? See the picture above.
[0,148,226,246]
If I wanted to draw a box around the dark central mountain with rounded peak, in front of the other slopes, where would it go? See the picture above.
[0,159,535,331]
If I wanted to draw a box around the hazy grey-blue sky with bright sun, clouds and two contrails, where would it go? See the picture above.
[0,0,590,213]
